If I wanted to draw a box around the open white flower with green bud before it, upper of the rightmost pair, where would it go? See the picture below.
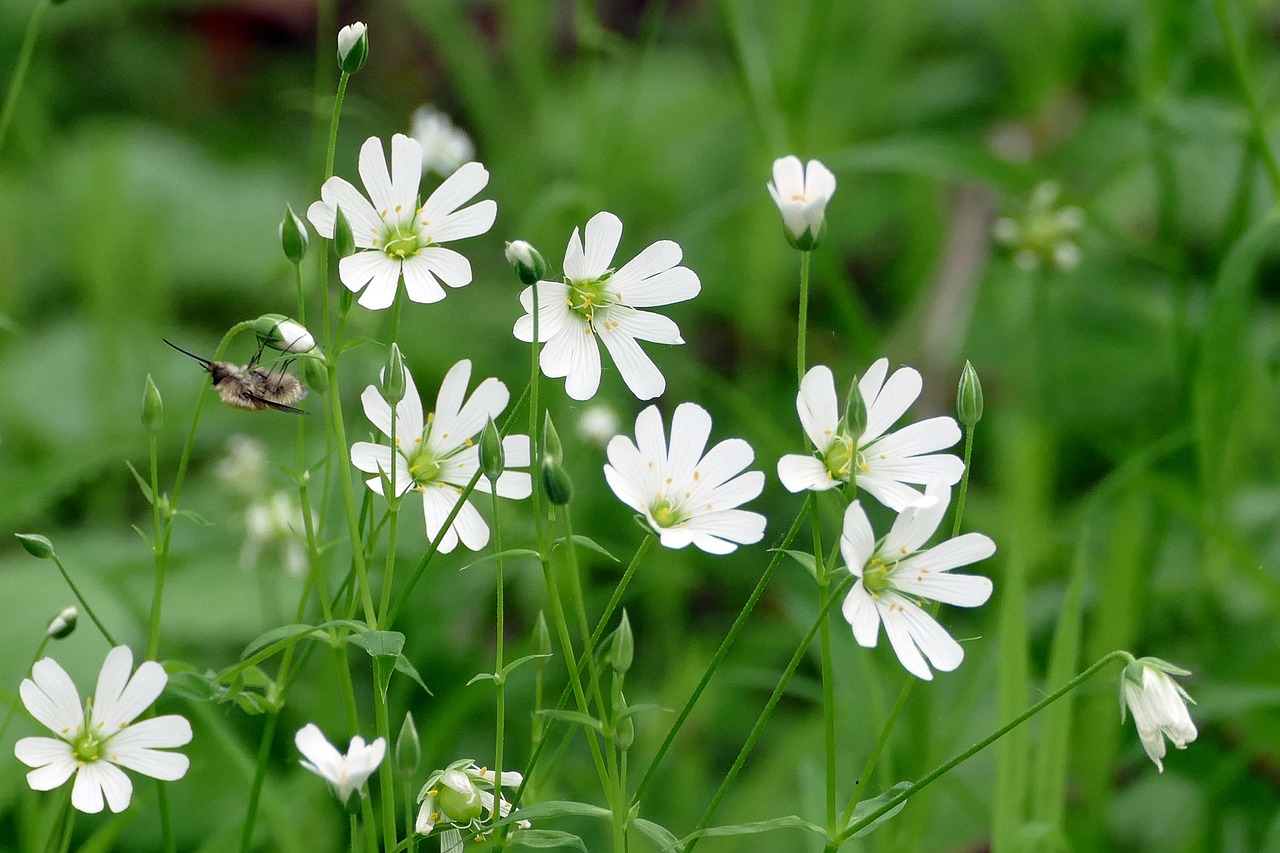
[778,359,964,510]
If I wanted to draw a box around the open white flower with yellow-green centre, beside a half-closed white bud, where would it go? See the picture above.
[515,211,701,400]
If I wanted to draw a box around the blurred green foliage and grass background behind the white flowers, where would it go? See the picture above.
[0,0,1280,853]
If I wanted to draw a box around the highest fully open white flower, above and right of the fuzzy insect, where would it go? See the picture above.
[307,133,498,310]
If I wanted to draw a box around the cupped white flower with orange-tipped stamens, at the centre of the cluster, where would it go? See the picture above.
[604,402,764,553]
